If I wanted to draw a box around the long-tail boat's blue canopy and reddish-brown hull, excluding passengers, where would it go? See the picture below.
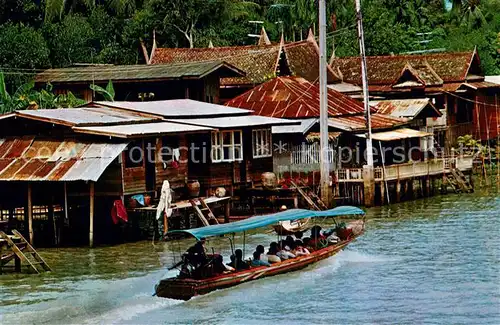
[155,206,364,300]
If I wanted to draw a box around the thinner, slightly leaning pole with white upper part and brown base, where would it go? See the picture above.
[355,0,375,206]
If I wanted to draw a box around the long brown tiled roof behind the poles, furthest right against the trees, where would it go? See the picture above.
[331,51,479,85]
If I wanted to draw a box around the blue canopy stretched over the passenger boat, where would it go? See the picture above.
[168,206,365,239]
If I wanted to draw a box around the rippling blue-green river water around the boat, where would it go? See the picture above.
[0,189,500,324]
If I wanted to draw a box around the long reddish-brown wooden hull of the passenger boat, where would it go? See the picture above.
[155,231,362,300]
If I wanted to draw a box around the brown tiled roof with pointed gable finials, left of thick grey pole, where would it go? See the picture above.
[151,39,339,85]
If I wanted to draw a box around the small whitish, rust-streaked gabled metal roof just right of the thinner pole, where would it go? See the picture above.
[370,98,442,119]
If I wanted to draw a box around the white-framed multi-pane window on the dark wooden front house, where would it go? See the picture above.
[212,131,243,162]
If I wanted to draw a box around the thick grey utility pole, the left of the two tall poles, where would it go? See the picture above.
[319,0,330,206]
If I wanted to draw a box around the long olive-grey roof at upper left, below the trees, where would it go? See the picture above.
[35,60,245,83]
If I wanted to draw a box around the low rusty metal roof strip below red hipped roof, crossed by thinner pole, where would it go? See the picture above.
[328,113,408,131]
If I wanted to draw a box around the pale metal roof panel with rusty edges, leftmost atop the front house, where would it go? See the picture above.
[15,107,159,126]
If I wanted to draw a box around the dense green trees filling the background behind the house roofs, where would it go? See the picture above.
[0,0,500,92]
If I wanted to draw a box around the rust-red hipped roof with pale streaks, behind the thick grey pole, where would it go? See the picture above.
[225,77,370,118]
